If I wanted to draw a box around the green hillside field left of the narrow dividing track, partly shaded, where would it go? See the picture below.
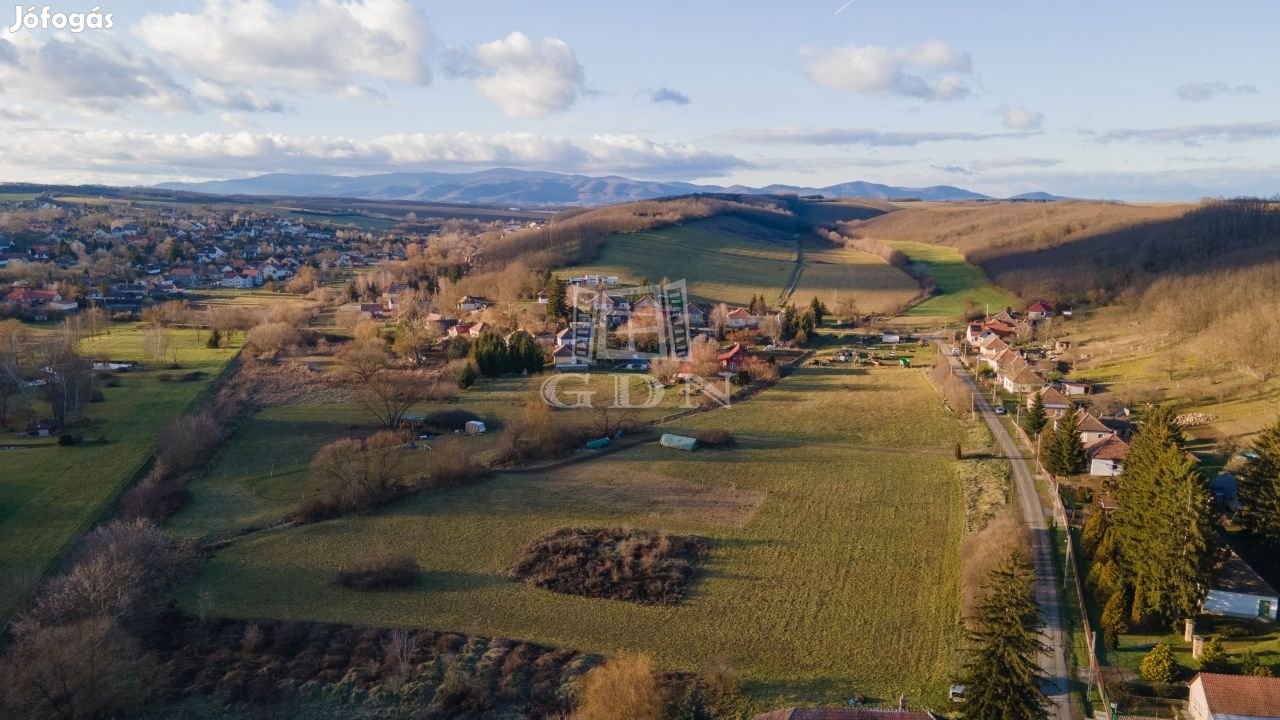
[559,212,796,305]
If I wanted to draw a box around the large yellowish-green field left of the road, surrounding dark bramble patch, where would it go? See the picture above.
[188,353,965,710]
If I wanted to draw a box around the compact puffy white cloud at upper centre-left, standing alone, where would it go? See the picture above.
[445,32,586,118]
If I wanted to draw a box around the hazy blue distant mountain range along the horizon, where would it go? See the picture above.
[156,168,1059,205]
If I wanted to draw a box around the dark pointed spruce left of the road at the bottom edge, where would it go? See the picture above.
[961,551,1048,720]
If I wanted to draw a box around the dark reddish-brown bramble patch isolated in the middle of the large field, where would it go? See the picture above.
[509,528,707,605]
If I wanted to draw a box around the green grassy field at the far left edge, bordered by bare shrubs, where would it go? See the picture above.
[0,325,236,618]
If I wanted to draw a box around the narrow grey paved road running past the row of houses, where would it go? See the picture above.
[950,357,1073,720]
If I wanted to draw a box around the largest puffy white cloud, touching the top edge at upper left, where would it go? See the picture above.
[134,0,434,90]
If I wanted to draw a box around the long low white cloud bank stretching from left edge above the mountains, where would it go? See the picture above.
[0,130,748,182]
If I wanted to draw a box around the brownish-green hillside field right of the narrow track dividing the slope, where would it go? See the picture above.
[791,238,920,313]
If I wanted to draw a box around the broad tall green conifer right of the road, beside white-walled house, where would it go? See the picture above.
[1114,406,1217,623]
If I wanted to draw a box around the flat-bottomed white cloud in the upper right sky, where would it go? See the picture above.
[800,40,973,100]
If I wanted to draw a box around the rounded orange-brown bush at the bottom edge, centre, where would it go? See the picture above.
[573,655,667,720]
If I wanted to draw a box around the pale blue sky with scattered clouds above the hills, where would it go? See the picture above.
[0,0,1280,201]
